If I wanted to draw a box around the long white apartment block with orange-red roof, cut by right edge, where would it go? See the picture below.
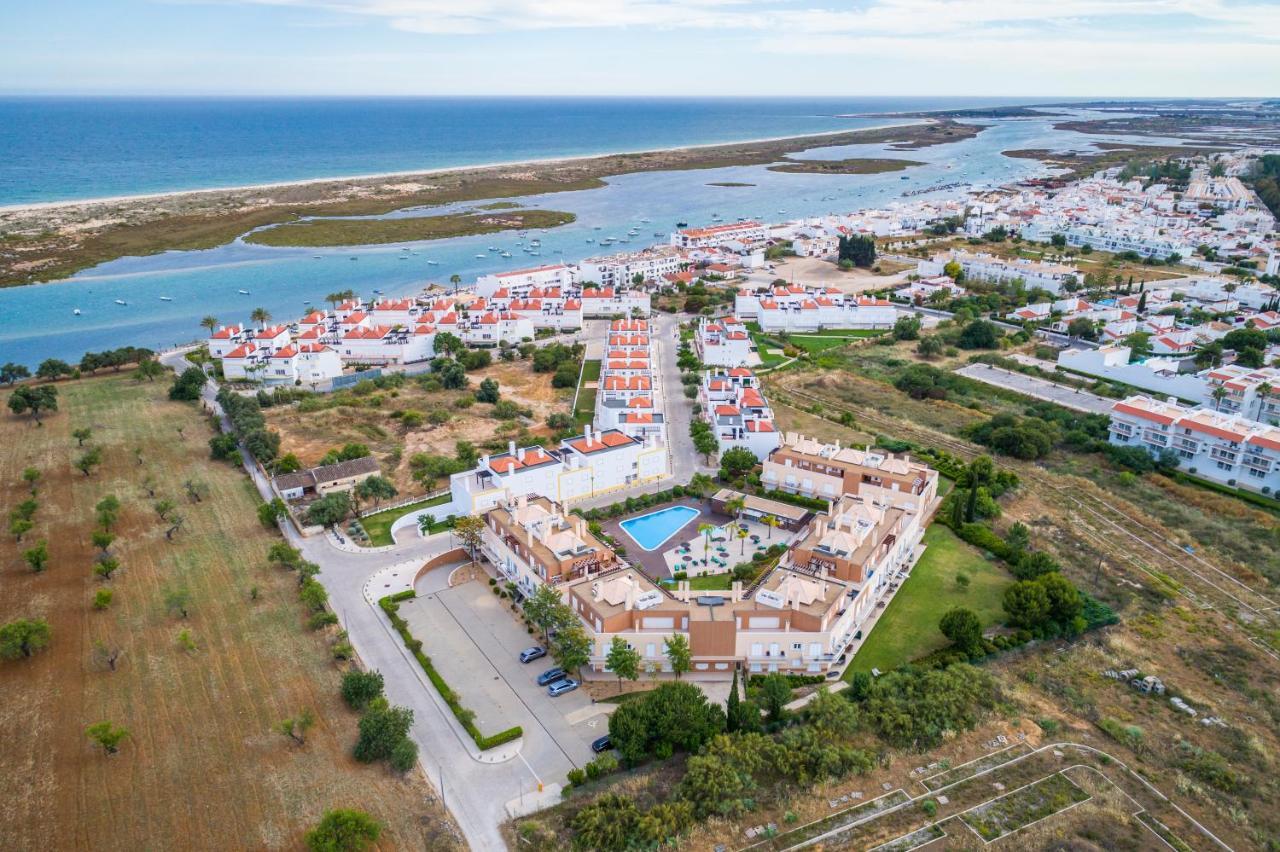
[1110,395,1280,494]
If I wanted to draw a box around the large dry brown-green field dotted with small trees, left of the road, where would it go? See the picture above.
[0,375,461,849]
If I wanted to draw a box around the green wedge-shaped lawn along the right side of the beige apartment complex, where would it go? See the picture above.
[845,523,1012,678]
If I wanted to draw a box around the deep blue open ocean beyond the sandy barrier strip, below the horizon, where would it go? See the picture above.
[0,97,1049,205]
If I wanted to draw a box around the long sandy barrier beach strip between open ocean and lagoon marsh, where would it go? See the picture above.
[0,119,967,287]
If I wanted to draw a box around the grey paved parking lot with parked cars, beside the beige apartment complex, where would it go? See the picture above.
[399,581,608,782]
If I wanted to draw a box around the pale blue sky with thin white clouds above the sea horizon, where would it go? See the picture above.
[0,0,1280,97]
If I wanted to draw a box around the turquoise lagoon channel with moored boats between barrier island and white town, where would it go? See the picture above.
[0,100,1187,365]
